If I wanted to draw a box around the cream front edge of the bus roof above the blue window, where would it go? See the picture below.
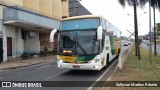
[62,15,102,21]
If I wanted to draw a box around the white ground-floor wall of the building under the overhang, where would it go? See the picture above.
[3,25,40,61]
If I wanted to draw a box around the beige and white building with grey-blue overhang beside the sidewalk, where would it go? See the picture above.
[0,0,91,61]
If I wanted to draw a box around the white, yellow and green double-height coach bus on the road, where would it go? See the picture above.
[50,15,121,70]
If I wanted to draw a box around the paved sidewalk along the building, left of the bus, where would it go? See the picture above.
[0,55,57,70]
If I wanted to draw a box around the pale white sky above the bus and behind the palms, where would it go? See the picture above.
[80,0,160,37]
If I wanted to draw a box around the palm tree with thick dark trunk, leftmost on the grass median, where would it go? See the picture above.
[118,0,160,60]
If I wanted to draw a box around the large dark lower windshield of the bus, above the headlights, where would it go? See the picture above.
[59,30,99,55]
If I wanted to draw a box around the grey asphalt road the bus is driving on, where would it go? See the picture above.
[0,46,130,90]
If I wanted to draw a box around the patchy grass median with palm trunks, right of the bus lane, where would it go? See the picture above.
[107,45,160,90]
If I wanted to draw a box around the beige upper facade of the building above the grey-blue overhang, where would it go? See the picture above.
[3,0,69,19]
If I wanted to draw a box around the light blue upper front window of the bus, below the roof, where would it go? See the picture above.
[61,18,99,31]
